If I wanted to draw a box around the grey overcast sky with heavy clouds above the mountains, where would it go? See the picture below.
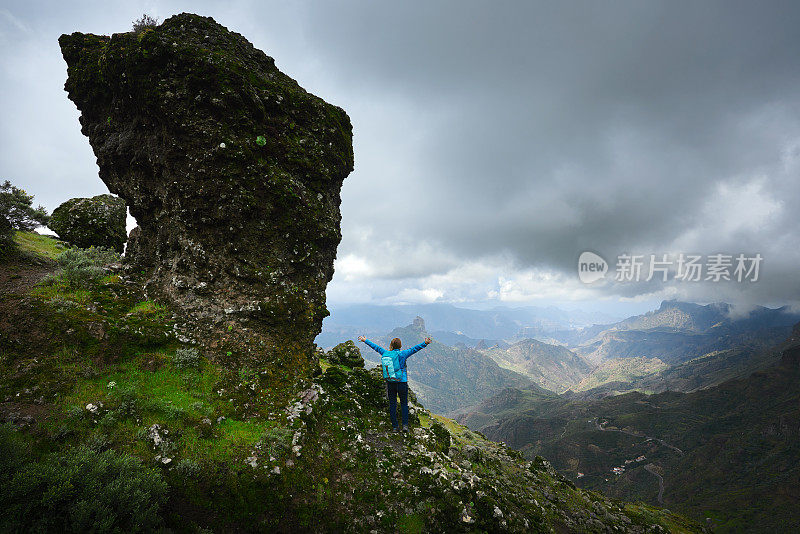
[0,0,800,313]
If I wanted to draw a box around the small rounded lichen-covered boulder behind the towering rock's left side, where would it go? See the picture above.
[47,195,128,253]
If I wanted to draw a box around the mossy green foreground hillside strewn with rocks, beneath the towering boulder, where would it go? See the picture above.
[0,236,702,532]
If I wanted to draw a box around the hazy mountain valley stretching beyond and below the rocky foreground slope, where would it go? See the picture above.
[322,301,800,532]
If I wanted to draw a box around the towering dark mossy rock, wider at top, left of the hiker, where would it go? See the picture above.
[59,13,353,382]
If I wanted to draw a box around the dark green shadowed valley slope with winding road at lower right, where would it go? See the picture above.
[458,325,800,532]
